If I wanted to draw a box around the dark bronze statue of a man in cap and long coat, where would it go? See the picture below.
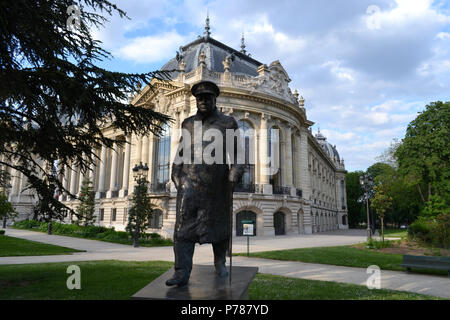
[166,81,244,286]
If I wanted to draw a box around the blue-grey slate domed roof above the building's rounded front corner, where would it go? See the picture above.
[161,36,262,79]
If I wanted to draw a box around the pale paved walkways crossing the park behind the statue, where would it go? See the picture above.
[0,229,450,298]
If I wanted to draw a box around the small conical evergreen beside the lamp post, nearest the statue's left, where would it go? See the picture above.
[126,178,153,247]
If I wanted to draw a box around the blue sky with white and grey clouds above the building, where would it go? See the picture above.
[89,0,450,171]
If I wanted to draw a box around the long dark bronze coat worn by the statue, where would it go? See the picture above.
[172,109,244,244]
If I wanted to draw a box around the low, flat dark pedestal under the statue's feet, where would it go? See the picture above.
[131,265,258,300]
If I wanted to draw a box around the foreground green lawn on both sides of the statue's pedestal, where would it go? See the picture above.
[0,261,442,300]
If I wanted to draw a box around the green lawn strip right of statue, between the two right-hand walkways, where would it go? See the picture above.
[236,246,447,275]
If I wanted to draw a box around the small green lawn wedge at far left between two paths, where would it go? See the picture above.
[0,235,84,257]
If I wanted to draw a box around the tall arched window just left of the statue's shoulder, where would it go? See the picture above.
[152,123,170,191]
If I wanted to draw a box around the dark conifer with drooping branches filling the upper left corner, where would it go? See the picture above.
[0,0,169,222]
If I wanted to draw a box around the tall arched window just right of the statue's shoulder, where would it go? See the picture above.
[238,120,255,192]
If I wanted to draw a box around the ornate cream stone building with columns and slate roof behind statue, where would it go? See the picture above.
[5,26,348,236]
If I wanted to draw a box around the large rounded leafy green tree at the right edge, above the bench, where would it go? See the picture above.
[395,101,450,207]
